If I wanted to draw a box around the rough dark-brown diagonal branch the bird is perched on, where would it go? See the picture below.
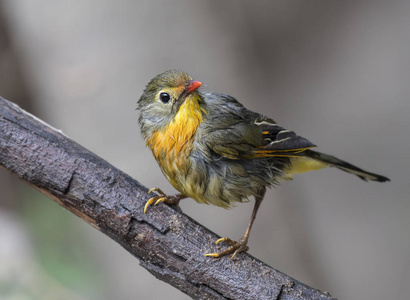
[0,97,334,300]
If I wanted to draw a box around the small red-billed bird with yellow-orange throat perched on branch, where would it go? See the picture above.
[137,70,390,258]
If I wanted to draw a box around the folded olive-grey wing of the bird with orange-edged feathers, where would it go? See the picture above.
[198,93,316,159]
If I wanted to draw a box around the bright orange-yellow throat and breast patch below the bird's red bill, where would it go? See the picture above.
[147,94,204,169]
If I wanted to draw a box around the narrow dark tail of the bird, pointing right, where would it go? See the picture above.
[303,149,390,182]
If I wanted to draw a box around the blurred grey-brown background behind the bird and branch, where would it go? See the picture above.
[0,0,410,299]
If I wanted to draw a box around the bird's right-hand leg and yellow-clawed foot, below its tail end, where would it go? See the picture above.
[205,189,266,259]
